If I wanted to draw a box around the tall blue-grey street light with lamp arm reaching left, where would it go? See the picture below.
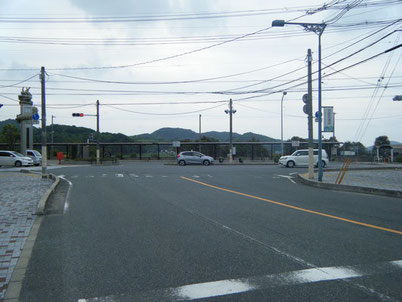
[272,20,327,182]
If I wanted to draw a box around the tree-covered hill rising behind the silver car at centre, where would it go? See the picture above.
[131,128,277,142]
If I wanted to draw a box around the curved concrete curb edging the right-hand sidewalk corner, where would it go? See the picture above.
[297,173,402,198]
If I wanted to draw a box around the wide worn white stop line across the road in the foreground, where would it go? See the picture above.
[78,260,402,302]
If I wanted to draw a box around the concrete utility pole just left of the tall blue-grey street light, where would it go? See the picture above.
[307,49,314,179]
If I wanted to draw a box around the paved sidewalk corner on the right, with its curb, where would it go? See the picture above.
[298,164,402,197]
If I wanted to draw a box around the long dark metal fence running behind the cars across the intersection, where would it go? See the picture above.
[0,142,342,160]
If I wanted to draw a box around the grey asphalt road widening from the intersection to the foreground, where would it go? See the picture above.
[20,163,402,302]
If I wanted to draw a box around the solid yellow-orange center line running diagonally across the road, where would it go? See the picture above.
[181,176,402,235]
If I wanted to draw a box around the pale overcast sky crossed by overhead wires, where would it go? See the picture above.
[0,0,402,146]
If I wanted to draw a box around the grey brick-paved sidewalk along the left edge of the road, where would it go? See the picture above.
[0,172,53,301]
